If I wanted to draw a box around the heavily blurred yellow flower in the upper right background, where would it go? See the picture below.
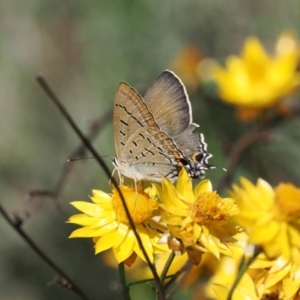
[214,34,300,118]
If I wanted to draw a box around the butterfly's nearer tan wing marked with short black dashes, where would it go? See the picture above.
[114,83,185,181]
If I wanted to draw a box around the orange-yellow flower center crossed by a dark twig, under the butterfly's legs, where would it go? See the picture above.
[112,186,157,225]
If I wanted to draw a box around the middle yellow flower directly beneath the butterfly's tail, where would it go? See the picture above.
[155,169,239,263]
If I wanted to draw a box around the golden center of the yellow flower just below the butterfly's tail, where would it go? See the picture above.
[191,192,233,225]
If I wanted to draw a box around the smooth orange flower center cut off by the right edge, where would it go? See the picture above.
[275,183,300,217]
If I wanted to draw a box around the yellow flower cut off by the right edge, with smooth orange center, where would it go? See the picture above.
[229,178,300,268]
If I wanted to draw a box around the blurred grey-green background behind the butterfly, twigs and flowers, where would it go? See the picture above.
[0,0,300,300]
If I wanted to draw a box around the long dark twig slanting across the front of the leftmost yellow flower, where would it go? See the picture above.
[36,75,165,300]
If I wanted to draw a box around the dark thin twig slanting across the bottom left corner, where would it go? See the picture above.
[0,204,89,300]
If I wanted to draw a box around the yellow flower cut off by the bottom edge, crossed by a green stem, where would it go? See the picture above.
[206,253,300,300]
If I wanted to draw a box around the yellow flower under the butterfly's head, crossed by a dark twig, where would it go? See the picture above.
[68,186,167,265]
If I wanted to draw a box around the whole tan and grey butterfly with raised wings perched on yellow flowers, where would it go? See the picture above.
[112,70,215,182]
